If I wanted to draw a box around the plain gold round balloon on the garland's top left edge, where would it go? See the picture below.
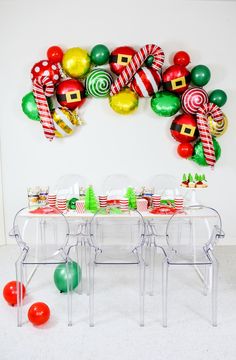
[62,48,90,78]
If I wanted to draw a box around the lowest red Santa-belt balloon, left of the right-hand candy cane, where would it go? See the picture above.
[170,114,198,143]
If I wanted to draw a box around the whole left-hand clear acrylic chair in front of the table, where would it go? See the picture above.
[10,208,77,326]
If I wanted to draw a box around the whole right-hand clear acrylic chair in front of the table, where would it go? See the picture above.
[151,205,224,327]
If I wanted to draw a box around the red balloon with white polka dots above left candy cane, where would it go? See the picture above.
[31,60,60,84]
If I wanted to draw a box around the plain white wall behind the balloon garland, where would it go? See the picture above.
[0,0,236,243]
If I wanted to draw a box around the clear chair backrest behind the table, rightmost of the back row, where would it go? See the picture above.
[146,174,179,199]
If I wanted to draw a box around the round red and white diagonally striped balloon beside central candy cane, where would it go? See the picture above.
[130,67,161,97]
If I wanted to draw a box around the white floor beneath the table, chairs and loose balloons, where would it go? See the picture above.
[0,246,236,360]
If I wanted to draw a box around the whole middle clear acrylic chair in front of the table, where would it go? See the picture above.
[85,210,146,326]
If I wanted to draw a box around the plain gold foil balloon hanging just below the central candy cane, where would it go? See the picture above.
[109,88,138,115]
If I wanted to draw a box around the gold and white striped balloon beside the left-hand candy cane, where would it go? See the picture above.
[52,107,81,138]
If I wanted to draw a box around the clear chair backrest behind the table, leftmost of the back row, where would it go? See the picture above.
[52,174,87,198]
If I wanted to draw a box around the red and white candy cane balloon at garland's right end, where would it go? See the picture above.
[197,103,224,166]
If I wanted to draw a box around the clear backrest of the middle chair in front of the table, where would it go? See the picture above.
[88,210,146,259]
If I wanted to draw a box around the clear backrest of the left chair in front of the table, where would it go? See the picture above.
[10,208,70,263]
